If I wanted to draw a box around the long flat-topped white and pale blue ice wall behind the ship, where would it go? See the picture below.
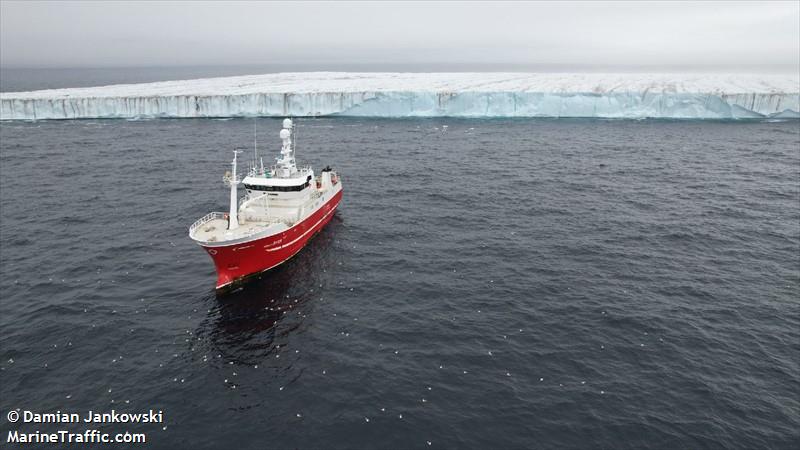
[0,72,800,120]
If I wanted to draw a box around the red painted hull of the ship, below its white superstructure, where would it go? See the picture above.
[203,190,342,289]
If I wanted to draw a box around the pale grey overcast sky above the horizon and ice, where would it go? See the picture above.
[0,0,800,72]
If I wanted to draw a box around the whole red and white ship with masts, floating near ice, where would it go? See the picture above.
[189,119,342,289]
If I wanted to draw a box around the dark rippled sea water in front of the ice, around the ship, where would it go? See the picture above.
[0,118,800,449]
